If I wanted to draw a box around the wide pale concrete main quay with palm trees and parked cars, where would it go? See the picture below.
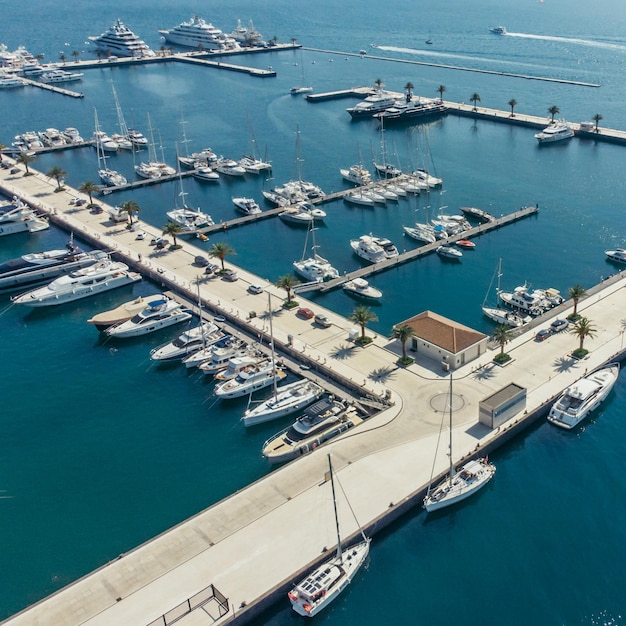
[0,160,626,626]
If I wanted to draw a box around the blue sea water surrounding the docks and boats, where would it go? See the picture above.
[0,0,626,625]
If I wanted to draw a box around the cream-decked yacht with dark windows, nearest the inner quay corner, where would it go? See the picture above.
[263,396,363,465]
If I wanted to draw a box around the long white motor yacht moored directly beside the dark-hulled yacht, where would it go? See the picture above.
[11,258,141,307]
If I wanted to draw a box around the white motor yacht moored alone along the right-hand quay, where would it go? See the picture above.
[548,363,620,430]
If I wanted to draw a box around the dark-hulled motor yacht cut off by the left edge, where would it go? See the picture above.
[0,240,107,293]
